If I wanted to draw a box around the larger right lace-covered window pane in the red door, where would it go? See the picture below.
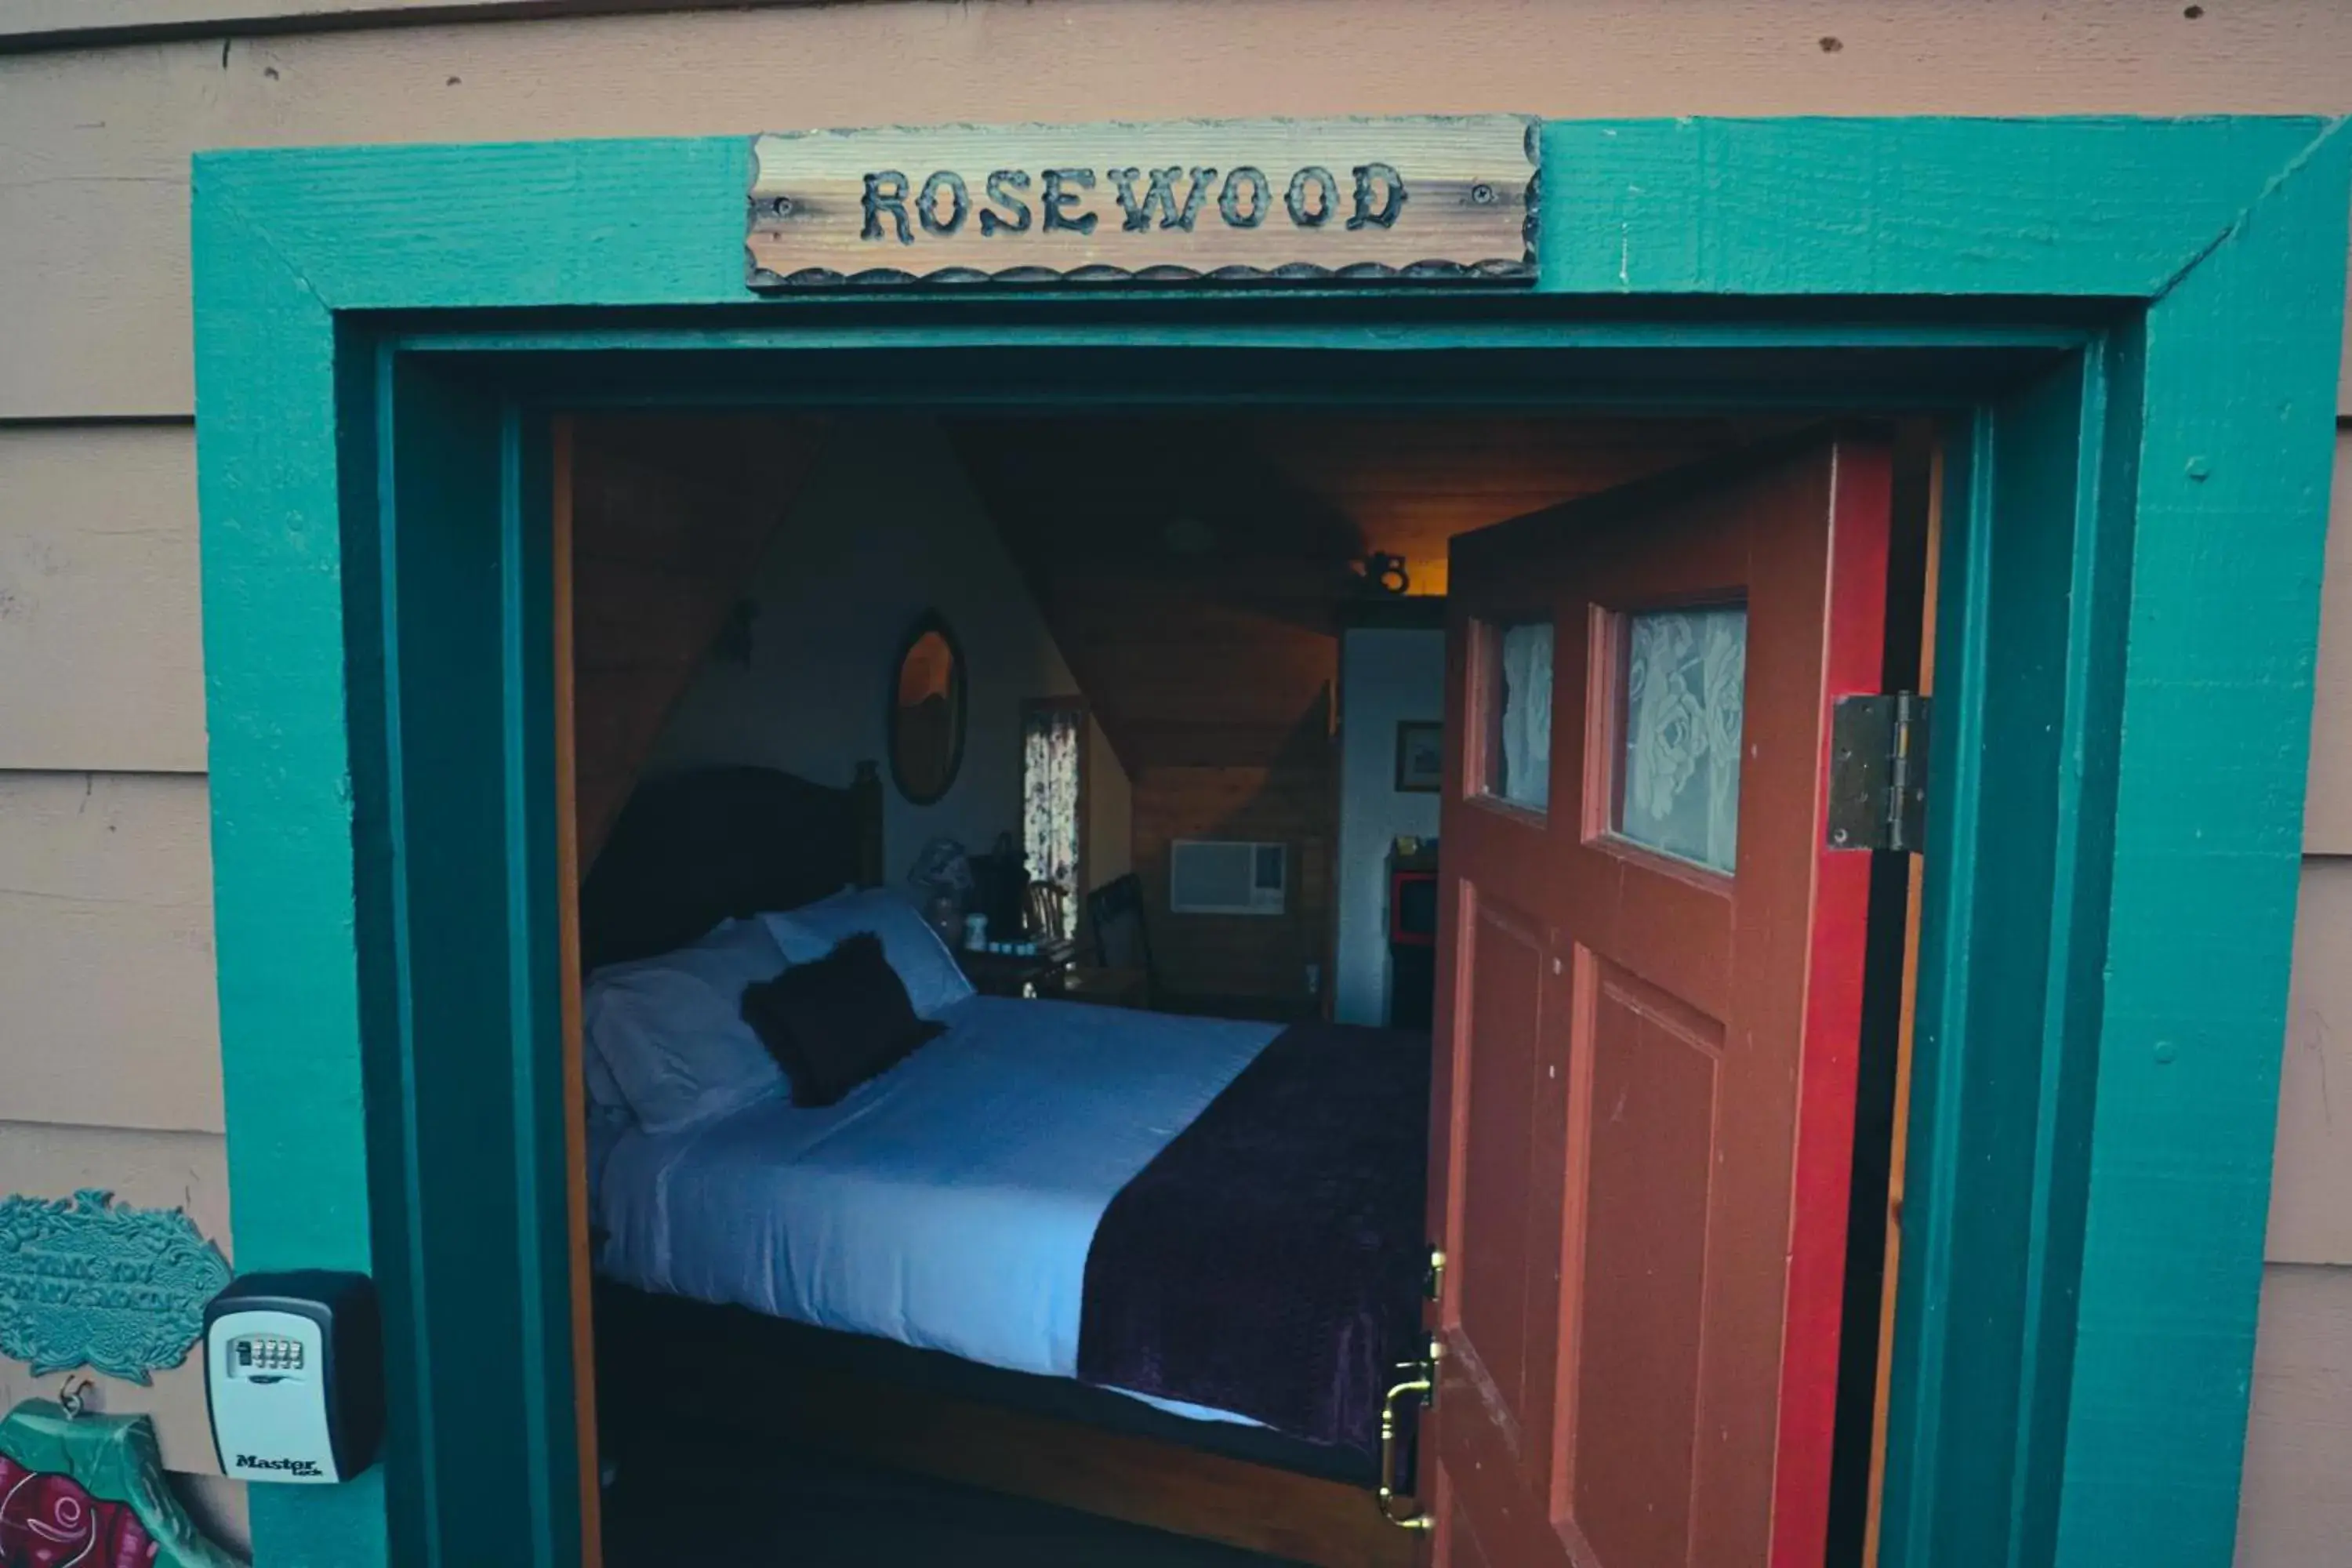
[1616,604,1748,872]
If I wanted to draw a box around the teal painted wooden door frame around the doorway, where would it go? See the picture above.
[193,120,2352,1568]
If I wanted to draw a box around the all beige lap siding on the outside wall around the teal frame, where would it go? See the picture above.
[0,0,2352,1568]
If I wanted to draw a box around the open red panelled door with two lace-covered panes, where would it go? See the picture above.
[1421,435,1891,1568]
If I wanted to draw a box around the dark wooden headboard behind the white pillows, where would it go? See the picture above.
[581,762,882,971]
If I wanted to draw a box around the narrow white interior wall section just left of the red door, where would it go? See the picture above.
[1331,628,1446,1022]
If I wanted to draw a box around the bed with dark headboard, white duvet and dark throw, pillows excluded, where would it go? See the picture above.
[581,769,1428,1561]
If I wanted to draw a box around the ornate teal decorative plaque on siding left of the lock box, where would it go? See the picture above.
[0,1187,228,1382]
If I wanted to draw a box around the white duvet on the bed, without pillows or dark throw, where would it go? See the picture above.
[593,996,1279,1420]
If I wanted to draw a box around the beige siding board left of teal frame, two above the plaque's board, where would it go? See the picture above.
[0,426,205,774]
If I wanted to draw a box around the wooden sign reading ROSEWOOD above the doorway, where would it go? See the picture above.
[746,115,1536,289]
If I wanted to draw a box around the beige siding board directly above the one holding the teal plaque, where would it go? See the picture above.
[0,774,221,1133]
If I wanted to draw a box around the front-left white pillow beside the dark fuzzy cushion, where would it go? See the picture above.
[583,919,788,1133]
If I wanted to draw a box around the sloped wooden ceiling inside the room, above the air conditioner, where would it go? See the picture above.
[950,414,1752,774]
